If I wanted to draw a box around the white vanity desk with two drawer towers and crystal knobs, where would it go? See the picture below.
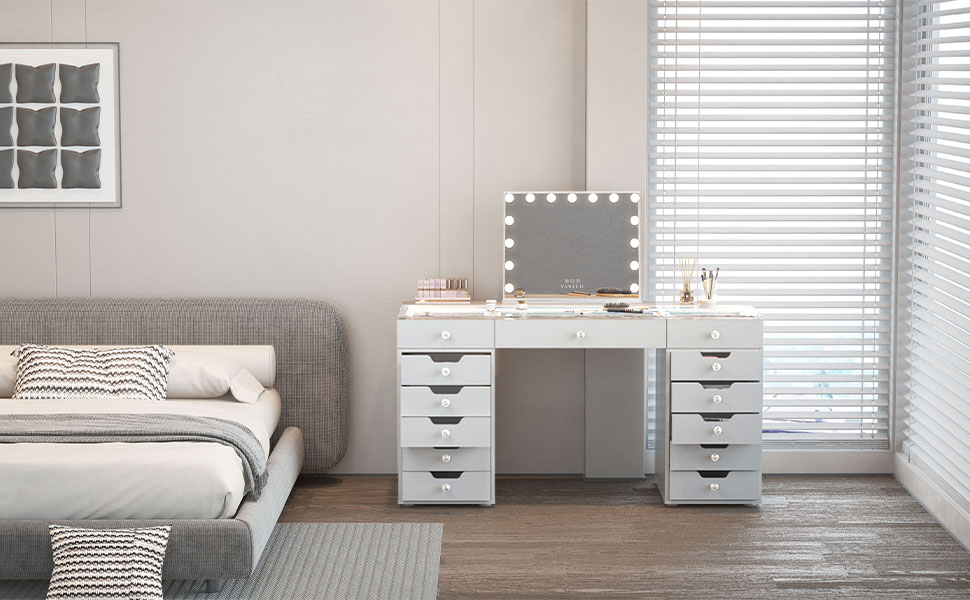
[397,304,762,505]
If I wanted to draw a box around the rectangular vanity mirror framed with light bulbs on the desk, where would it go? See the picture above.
[503,191,642,301]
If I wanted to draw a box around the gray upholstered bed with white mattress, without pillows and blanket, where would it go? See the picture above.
[0,298,349,589]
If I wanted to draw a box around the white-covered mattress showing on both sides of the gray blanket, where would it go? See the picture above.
[0,389,281,519]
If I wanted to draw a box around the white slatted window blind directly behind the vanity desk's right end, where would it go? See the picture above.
[647,0,896,448]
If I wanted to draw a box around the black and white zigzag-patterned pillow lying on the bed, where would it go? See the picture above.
[12,344,175,401]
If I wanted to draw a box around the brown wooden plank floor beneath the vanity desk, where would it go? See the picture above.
[282,476,970,600]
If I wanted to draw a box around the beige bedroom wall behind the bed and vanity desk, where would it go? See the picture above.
[0,0,645,473]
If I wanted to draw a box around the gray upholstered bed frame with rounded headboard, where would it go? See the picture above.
[0,298,349,589]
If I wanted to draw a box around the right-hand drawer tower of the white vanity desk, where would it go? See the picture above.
[656,319,762,504]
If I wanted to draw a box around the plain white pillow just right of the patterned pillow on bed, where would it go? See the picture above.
[167,350,265,404]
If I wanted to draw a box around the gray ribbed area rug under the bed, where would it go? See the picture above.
[0,523,444,600]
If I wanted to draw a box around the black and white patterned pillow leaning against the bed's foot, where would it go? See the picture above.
[47,525,171,600]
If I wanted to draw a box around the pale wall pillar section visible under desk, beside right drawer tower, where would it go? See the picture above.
[584,349,646,479]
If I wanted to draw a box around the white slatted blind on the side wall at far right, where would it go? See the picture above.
[900,0,970,508]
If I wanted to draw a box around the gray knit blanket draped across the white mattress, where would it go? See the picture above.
[0,413,269,499]
